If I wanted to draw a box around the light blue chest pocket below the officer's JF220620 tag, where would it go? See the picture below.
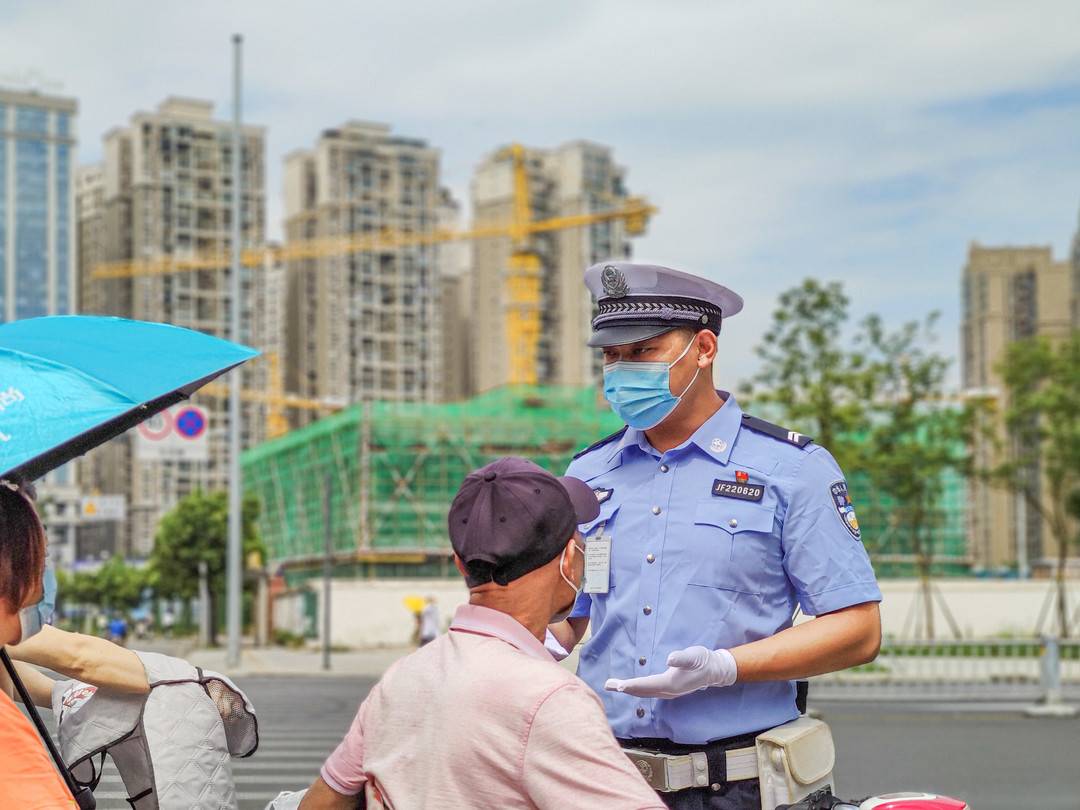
[690,497,780,594]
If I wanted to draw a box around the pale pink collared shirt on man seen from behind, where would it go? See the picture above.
[322,605,664,810]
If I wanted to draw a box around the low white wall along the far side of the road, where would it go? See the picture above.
[295,579,1080,648]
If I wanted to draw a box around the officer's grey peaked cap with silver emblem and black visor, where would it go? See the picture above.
[585,261,742,347]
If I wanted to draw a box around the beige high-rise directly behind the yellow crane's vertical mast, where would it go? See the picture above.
[469,140,630,393]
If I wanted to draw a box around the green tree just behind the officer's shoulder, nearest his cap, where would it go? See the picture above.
[744,279,866,469]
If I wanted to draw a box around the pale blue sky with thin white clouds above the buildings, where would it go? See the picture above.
[0,0,1080,386]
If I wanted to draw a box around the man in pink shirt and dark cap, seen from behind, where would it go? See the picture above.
[300,458,664,810]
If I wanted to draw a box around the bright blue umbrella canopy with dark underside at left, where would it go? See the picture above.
[0,315,258,480]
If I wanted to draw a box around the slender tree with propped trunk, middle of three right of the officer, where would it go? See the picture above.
[855,312,973,639]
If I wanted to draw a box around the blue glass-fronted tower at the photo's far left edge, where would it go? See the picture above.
[0,90,78,322]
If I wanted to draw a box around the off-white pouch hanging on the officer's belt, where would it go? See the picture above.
[755,717,836,810]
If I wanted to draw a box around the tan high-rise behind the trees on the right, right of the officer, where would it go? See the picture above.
[961,244,1071,570]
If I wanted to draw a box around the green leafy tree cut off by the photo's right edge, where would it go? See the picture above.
[981,332,1080,637]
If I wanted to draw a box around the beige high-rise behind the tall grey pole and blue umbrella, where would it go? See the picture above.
[79,97,266,555]
